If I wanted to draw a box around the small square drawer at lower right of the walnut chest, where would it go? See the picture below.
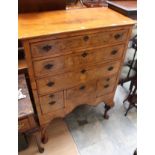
[96,75,117,97]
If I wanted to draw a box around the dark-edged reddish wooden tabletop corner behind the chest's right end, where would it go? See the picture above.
[107,0,137,20]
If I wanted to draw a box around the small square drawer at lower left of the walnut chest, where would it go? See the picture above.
[40,91,64,114]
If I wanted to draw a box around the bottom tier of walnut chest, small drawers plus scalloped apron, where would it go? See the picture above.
[39,74,117,124]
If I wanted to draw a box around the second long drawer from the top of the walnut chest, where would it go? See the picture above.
[34,45,124,77]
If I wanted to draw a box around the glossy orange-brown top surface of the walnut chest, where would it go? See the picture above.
[18,7,135,39]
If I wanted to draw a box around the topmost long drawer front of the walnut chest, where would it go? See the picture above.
[31,29,128,58]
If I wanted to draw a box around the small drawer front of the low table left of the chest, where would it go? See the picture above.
[18,118,31,132]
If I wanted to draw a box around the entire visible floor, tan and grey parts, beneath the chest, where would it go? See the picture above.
[19,83,137,155]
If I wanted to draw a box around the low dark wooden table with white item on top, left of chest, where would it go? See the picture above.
[18,74,44,153]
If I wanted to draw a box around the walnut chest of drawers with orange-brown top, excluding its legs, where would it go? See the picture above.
[19,8,134,142]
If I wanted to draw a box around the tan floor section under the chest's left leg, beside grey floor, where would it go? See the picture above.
[19,119,79,155]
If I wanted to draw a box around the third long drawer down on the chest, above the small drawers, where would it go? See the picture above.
[37,62,120,95]
